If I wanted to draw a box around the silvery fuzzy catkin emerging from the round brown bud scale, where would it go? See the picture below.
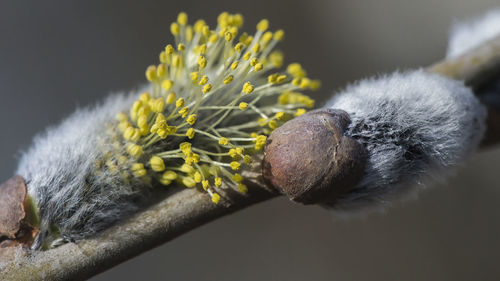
[328,70,486,210]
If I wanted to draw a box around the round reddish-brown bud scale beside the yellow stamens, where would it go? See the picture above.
[262,109,366,204]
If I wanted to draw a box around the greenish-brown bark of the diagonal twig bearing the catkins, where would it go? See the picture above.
[0,34,500,281]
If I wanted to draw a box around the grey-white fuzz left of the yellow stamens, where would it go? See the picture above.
[17,90,143,248]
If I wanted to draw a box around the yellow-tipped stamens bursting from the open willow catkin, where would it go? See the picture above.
[111,12,321,204]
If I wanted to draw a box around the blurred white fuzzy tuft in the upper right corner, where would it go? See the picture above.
[446,9,500,57]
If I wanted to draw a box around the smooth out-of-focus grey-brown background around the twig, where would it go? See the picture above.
[0,0,500,281]
